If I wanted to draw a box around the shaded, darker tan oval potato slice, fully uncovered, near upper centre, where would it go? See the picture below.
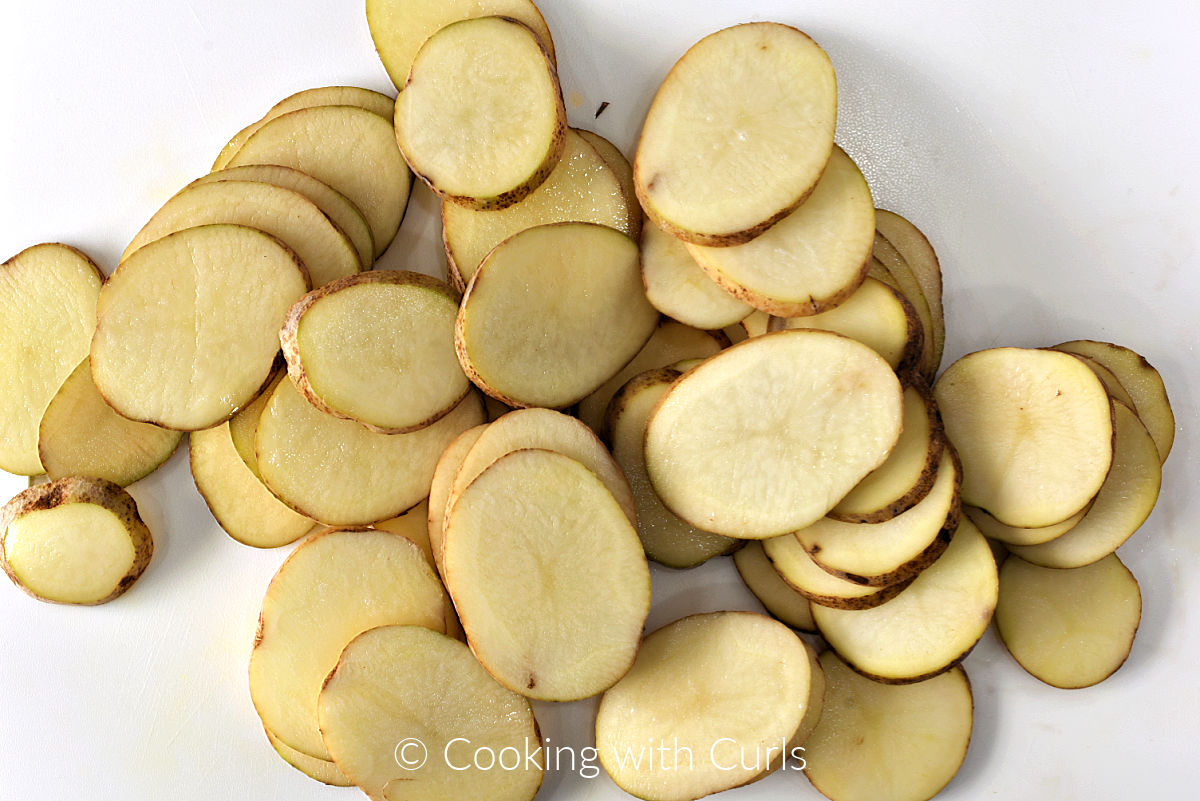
[455,223,658,409]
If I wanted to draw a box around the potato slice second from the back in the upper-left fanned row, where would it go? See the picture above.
[229,106,412,258]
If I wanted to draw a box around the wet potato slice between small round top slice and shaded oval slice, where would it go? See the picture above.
[442,128,641,289]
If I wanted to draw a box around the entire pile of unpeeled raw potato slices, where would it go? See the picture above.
[0,0,1175,801]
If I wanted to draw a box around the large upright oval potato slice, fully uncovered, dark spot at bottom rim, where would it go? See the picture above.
[443,450,650,700]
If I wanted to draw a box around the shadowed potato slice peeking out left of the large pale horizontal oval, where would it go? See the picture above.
[605,368,739,568]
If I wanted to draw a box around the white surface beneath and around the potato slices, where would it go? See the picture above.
[0,0,1200,801]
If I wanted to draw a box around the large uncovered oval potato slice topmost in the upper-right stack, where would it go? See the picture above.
[634,23,838,246]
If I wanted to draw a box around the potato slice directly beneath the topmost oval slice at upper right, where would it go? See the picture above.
[686,145,875,317]
